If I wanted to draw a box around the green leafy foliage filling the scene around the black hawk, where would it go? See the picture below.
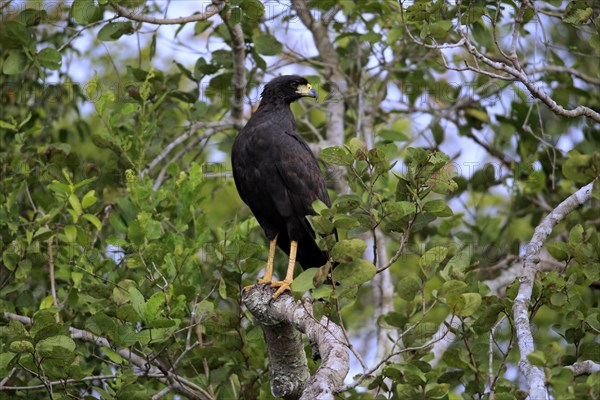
[0,0,600,399]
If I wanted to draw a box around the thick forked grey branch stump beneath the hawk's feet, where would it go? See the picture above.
[242,285,349,400]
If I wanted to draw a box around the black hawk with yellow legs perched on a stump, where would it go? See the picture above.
[231,75,331,298]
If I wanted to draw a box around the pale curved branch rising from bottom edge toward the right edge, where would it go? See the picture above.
[513,182,594,399]
